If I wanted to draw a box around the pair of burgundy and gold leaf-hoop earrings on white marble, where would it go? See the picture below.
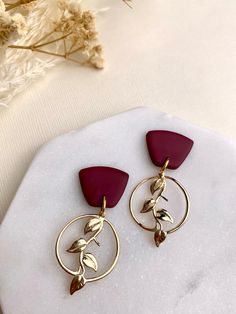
[55,130,193,294]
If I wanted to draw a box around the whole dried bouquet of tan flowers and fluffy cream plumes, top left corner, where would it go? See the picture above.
[0,0,131,106]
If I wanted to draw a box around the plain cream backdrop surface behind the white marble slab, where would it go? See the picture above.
[0,0,236,221]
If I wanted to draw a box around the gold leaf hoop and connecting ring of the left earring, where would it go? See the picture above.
[55,196,120,294]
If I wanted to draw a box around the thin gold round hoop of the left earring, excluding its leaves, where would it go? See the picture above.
[55,215,120,282]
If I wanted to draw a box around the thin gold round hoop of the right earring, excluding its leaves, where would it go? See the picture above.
[129,175,190,234]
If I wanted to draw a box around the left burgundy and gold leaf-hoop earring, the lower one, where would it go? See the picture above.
[55,167,129,294]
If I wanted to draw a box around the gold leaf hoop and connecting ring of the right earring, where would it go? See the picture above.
[129,159,190,246]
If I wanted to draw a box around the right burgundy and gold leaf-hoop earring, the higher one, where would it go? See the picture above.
[129,130,193,247]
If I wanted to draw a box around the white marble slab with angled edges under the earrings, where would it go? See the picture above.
[0,108,236,314]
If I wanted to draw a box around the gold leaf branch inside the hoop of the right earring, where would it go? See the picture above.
[140,176,173,247]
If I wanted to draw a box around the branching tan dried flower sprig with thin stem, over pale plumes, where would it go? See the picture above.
[8,0,104,69]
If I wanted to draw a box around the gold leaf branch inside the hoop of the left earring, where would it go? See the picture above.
[67,217,104,294]
